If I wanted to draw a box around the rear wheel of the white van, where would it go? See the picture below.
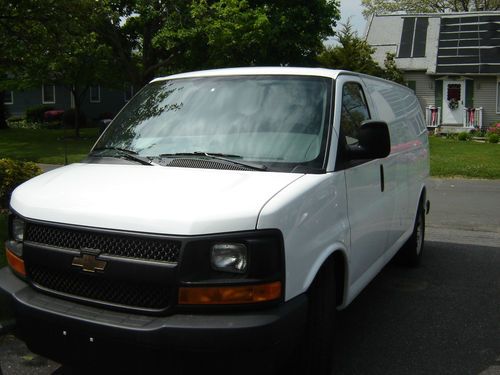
[397,201,425,267]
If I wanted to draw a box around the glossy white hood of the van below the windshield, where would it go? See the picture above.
[11,164,303,235]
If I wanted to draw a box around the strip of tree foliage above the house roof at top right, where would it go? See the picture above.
[361,0,500,18]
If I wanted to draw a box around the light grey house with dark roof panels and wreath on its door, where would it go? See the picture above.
[366,12,500,131]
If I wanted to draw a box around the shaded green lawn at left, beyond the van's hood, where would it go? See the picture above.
[0,128,98,164]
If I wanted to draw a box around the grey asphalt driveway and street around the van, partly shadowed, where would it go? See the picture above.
[0,179,500,375]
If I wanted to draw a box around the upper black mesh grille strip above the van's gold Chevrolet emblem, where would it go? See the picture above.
[25,223,181,263]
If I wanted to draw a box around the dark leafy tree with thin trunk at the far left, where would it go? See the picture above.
[0,0,113,136]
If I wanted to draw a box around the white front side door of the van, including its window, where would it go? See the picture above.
[337,76,395,290]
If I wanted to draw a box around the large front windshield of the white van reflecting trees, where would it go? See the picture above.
[94,76,332,172]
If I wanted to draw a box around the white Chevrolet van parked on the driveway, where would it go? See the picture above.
[0,68,429,374]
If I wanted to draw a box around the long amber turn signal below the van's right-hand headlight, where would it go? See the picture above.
[179,281,281,305]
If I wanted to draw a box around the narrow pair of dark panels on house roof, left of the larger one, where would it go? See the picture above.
[398,17,429,58]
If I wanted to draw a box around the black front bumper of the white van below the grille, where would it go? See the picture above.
[0,267,307,368]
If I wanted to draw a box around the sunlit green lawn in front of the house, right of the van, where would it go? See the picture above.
[429,137,500,179]
